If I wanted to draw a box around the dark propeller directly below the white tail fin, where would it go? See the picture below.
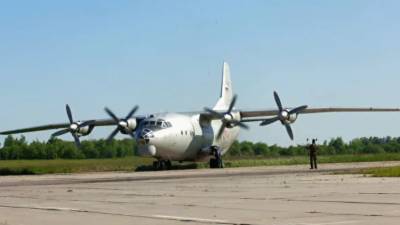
[204,95,249,139]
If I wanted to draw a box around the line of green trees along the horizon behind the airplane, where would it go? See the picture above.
[0,136,400,160]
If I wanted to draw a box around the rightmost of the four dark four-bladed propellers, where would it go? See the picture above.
[260,91,308,140]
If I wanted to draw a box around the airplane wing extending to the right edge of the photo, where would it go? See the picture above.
[240,107,400,122]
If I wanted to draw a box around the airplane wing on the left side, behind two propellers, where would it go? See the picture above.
[0,119,116,135]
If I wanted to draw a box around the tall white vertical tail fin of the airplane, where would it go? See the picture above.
[214,62,233,110]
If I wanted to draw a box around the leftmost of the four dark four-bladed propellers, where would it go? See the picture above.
[50,104,96,148]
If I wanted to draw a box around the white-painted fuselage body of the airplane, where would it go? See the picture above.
[136,113,240,161]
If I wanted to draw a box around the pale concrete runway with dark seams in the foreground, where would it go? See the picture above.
[0,162,400,225]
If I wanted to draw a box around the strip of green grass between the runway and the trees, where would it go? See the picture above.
[0,154,400,175]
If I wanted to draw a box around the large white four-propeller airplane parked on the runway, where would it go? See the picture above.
[0,62,400,170]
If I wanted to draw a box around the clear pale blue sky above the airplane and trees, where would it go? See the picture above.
[0,0,400,145]
